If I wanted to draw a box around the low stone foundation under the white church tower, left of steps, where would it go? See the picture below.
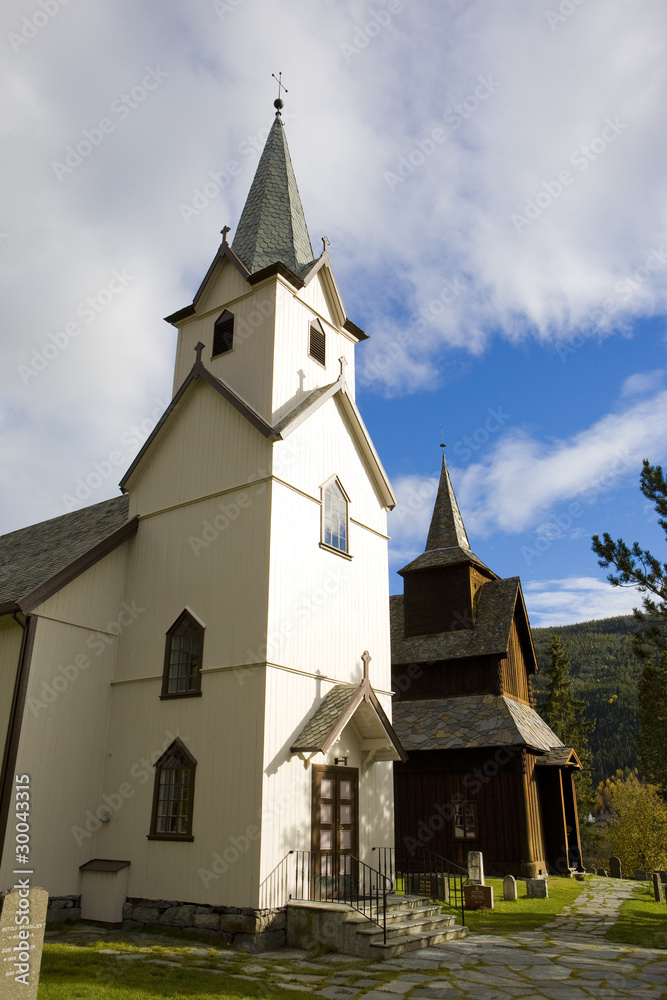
[123,898,287,953]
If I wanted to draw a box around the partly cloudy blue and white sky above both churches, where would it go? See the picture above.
[0,0,667,626]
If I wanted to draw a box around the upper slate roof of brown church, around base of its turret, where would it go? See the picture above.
[389,576,519,664]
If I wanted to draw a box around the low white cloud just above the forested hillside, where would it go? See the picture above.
[523,576,642,628]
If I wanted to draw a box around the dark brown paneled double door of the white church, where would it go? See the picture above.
[311,765,359,899]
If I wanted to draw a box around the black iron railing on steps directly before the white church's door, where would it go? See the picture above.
[261,851,393,943]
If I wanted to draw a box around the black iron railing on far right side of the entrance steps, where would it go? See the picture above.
[372,847,468,926]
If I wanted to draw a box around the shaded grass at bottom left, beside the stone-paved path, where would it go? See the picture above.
[37,933,328,1000]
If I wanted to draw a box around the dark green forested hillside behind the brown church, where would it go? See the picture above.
[532,615,641,784]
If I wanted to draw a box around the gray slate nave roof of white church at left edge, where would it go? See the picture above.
[0,496,130,607]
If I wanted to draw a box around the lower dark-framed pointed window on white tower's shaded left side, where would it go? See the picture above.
[148,737,197,840]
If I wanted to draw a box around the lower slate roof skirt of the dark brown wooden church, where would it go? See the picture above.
[393,694,563,752]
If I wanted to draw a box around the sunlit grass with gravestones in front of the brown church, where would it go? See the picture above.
[444,877,585,934]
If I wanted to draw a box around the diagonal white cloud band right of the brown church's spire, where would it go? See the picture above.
[456,392,667,536]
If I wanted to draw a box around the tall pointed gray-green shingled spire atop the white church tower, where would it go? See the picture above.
[232,113,313,277]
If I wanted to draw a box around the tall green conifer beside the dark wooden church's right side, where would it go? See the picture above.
[542,635,595,816]
